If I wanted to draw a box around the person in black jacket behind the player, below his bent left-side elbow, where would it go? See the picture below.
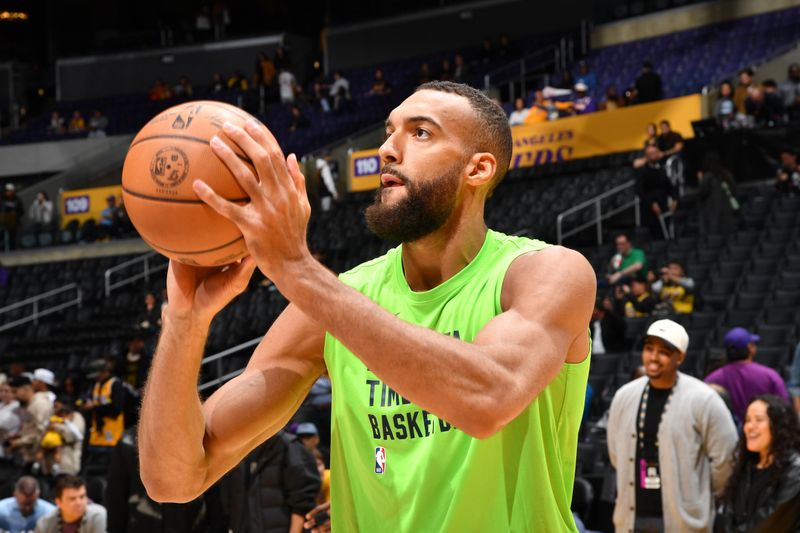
[226,431,321,533]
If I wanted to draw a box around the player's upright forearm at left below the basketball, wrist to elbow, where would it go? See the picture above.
[139,315,208,500]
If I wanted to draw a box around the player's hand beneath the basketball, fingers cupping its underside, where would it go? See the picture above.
[166,256,256,324]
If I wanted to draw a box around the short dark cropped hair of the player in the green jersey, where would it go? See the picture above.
[414,81,514,190]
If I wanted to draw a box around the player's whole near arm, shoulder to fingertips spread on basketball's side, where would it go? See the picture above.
[194,123,595,438]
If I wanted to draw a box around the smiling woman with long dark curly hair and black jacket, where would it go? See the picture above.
[720,394,800,533]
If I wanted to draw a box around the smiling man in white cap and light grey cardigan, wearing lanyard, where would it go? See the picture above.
[608,320,737,533]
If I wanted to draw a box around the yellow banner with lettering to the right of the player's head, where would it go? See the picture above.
[511,94,701,168]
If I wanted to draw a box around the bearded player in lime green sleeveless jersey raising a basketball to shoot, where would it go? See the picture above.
[140,82,595,532]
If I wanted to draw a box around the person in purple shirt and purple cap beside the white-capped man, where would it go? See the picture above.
[705,327,789,422]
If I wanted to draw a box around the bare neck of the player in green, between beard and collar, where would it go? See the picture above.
[403,209,487,292]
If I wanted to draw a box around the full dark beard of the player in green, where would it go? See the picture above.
[364,161,463,242]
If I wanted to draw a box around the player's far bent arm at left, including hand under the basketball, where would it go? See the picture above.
[139,262,324,502]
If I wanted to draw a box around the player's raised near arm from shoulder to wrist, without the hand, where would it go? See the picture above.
[278,243,595,438]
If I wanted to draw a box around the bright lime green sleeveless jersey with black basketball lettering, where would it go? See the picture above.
[325,230,589,533]
